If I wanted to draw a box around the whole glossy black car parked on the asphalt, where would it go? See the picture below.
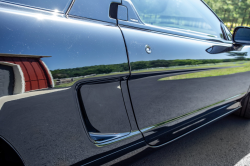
[0,0,250,166]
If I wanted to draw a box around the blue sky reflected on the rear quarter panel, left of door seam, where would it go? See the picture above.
[0,8,127,70]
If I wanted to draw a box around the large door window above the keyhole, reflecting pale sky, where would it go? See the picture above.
[131,0,224,39]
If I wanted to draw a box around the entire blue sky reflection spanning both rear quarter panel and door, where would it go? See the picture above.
[0,8,248,70]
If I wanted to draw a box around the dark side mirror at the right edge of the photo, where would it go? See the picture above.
[233,27,250,45]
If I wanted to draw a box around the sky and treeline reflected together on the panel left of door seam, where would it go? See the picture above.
[0,2,129,94]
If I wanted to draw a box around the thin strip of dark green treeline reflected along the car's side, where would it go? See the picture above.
[51,58,250,78]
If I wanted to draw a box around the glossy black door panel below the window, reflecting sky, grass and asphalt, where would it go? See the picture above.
[118,21,250,146]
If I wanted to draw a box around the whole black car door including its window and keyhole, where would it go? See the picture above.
[118,0,250,146]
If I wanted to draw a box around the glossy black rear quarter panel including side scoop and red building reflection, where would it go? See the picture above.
[0,1,142,165]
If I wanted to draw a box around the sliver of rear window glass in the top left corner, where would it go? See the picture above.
[0,0,71,11]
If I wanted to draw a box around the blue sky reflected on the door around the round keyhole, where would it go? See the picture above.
[122,28,249,62]
